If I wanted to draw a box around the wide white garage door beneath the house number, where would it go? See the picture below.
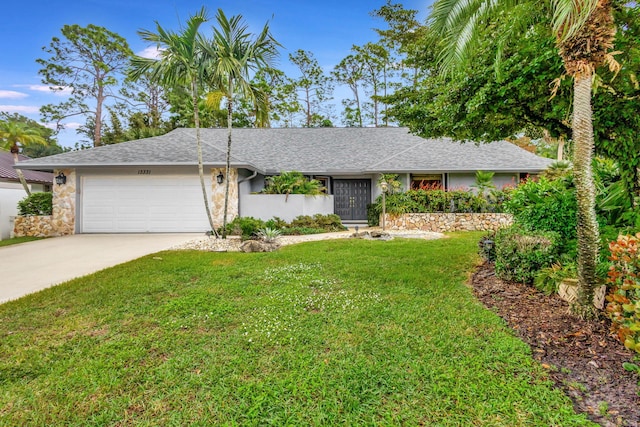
[80,175,210,233]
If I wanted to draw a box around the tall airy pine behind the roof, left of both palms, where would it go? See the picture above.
[36,24,132,147]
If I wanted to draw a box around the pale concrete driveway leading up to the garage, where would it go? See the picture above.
[0,233,202,304]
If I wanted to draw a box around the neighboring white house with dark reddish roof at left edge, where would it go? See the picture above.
[0,151,53,240]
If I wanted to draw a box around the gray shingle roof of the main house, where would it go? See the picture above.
[20,128,551,174]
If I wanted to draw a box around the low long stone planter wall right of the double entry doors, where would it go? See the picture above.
[381,213,513,232]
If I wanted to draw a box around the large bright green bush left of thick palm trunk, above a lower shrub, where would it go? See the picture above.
[505,177,577,240]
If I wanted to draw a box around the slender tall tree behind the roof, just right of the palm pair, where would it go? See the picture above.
[289,49,333,127]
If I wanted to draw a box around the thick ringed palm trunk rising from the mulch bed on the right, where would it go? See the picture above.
[571,72,599,318]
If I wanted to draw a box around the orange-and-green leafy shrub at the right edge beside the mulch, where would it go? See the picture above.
[606,233,640,353]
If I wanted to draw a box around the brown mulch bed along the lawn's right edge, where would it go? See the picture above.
[471,263,640,426]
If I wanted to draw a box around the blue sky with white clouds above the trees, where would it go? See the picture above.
[0,0,431,146]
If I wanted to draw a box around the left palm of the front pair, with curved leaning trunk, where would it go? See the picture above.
[129,7,218,237]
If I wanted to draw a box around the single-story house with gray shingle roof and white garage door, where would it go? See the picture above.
[18,128,551,234]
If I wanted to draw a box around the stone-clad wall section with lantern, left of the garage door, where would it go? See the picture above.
[51,169,77,236]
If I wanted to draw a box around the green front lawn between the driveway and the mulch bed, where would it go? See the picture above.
[0,234,595,426]
